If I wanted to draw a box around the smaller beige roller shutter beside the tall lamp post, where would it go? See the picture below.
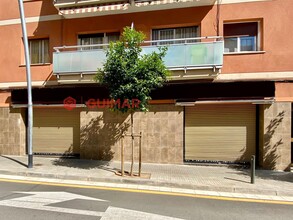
[33,108,80,154]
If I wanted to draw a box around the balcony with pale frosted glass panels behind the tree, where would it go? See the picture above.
[53,37,224,79]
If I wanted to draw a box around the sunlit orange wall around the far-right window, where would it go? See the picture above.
[221,0,293,73]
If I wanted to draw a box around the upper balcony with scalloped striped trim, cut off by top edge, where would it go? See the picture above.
[53,0,217,19]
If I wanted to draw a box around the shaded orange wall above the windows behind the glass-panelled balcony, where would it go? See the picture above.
[64,6,212,45]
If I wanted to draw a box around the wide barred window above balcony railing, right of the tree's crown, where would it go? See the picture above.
[152,26,198,45]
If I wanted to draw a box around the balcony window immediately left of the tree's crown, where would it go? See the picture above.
[78,32,120,50]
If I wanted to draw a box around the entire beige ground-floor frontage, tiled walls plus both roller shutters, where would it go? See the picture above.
[0,102,292,170]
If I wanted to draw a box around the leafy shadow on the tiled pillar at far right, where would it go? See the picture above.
[263,111,285,169]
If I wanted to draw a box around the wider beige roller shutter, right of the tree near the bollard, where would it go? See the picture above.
[185,104,256,162]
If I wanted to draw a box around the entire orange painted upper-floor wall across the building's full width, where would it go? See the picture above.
[0,0,293,83]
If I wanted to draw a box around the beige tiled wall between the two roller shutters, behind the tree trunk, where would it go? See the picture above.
[80,105,183,163]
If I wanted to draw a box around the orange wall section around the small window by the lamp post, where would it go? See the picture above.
[0,21,61,82]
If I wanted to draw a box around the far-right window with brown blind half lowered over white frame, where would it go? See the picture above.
[224,22,259,53]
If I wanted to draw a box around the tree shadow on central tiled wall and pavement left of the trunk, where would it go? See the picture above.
[53,111,130,169]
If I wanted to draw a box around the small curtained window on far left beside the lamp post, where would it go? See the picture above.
[29,39,50,64]
